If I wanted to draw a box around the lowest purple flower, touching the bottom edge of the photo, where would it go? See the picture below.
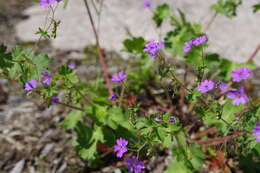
[125,156,145,173]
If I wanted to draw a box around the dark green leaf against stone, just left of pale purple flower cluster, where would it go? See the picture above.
[123,37,145,53]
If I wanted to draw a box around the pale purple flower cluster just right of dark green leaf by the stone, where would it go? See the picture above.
[144,40,164,59]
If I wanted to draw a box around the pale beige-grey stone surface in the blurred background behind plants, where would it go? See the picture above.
[16,0,260,65]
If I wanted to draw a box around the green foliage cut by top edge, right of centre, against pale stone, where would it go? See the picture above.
[211,0,242,18]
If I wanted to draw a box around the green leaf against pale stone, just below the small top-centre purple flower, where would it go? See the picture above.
[153,4,171,27]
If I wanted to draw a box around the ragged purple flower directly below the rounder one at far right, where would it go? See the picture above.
[227,86,248,105]
